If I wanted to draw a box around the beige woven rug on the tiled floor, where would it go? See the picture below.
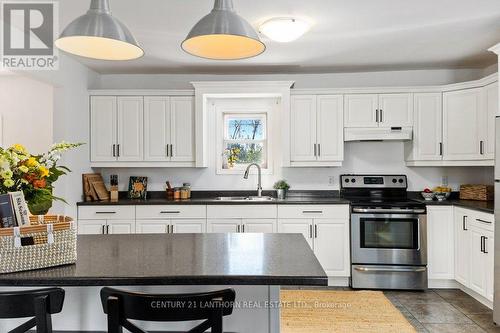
[281,290,416,333]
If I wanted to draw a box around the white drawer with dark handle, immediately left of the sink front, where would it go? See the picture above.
[136,205,207,219]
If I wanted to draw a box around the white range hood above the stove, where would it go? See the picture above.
[344,127,413,141]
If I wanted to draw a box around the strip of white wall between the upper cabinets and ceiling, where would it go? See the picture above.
[92,69,485,89]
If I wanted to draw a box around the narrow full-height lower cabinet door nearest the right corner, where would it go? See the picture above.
[455,208,472,287]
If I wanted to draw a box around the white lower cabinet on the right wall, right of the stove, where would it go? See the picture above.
[454,207,495,301]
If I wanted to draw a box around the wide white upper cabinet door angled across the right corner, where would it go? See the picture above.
[443,89,483,160]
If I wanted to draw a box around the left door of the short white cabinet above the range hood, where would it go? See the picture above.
[344,94,378,127]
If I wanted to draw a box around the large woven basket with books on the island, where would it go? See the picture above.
[0,215,76,273]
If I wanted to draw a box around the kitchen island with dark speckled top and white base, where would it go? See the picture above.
[0,233,328,333]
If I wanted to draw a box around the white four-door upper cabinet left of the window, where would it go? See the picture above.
[90,96,195,167]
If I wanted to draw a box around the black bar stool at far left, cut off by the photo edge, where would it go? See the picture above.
[0,288,64,333]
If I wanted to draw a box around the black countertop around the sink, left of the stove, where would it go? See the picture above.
[77,191,350,206]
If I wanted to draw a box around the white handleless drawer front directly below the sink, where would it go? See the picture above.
[207,205,277,219]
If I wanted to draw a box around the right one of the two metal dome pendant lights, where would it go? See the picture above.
[181,0,266,60]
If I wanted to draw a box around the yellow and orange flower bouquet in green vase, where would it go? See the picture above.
[0,142,82,215]
